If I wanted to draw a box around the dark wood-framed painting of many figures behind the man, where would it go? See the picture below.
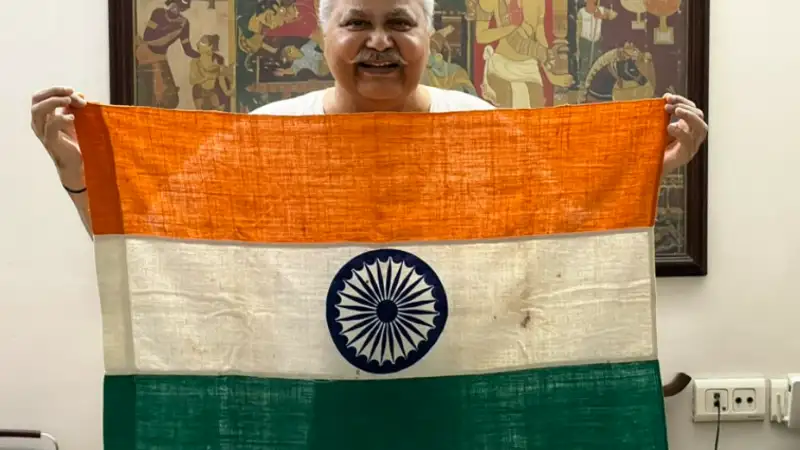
[108,0,710,277]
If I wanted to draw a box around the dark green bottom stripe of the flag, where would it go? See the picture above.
[104,361,667,450]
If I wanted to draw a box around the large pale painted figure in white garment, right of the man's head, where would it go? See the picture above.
[475,0,572,108]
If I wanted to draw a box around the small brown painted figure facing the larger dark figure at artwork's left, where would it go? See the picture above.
[189,34,234,111]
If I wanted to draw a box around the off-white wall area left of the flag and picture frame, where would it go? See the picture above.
[0,0,109,450]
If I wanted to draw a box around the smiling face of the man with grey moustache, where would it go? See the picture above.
[325,0,430,102]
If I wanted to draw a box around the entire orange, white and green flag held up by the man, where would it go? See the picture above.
[76,99,668,450]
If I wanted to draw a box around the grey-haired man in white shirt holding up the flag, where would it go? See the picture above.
[31,0,707,236]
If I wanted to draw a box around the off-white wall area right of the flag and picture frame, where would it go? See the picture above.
[658,0,800,450]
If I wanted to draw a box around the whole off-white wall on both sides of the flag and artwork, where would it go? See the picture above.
[0,0,800,450]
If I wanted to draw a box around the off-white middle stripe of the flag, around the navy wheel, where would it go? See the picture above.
[96,229,656,379]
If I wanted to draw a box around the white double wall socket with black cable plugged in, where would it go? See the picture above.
[692,378,767,422]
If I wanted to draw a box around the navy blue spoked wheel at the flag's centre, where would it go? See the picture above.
[327,249,447,374]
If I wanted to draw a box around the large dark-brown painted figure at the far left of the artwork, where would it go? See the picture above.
[135,0,200,109]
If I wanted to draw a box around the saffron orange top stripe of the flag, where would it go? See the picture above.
[76,99,667,243]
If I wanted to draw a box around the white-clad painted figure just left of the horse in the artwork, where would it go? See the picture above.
[577,0,617,83]
